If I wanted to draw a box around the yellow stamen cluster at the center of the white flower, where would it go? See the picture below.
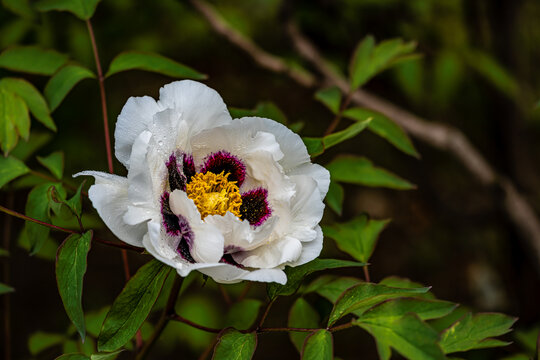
[186,171,242,219]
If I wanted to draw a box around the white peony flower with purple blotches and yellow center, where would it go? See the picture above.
[76,80,330,284]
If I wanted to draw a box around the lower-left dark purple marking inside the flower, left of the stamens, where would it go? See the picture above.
[161,192,195,263]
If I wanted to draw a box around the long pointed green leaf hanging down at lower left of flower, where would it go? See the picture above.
[56,231,93,342]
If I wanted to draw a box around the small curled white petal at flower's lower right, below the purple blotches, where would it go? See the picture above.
[232,236,302,269]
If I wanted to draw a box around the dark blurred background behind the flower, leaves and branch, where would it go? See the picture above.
[0,0,540,359]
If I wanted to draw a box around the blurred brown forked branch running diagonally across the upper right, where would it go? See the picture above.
[191,0,540,271]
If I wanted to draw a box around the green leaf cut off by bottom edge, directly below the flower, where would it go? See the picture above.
[212,329,257,360]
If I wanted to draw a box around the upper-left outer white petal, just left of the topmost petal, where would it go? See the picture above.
[114,96,162,169]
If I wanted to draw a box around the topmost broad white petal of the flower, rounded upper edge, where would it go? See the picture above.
[159,80,231,138]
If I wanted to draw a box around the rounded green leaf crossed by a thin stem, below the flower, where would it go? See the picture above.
[288,298,320,353]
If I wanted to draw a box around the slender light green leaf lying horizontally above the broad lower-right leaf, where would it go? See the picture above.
[357,298,457,322]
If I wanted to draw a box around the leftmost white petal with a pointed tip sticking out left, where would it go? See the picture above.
[75,171,147,246]
